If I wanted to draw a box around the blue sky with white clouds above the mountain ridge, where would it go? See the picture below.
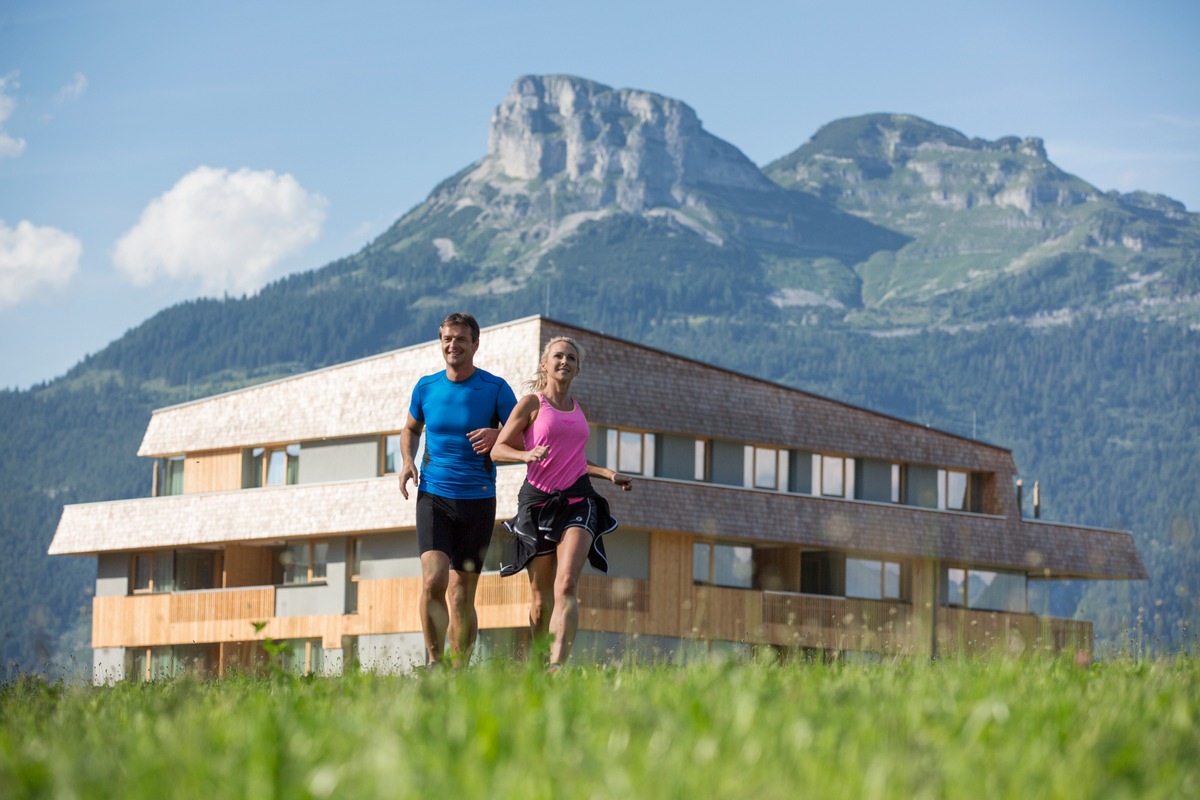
[0,0,1200,389]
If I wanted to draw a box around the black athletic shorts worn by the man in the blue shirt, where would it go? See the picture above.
[416,492,496,573]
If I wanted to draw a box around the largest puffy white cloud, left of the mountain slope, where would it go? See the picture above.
[113,167,328,294]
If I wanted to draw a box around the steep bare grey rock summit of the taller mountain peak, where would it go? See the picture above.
[488,76,774,211]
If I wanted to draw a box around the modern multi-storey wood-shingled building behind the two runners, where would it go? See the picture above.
[49,317,1146,682]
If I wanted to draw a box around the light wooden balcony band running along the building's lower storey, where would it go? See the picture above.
[92,575,1092,655]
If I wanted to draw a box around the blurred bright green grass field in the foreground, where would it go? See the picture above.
[0,657,1200,800]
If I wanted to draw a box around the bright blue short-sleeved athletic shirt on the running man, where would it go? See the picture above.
[408,367,517,500]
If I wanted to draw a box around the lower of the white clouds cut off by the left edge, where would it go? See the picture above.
[0,219,83,308]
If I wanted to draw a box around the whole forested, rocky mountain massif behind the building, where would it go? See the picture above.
[0,76,1200,672]
